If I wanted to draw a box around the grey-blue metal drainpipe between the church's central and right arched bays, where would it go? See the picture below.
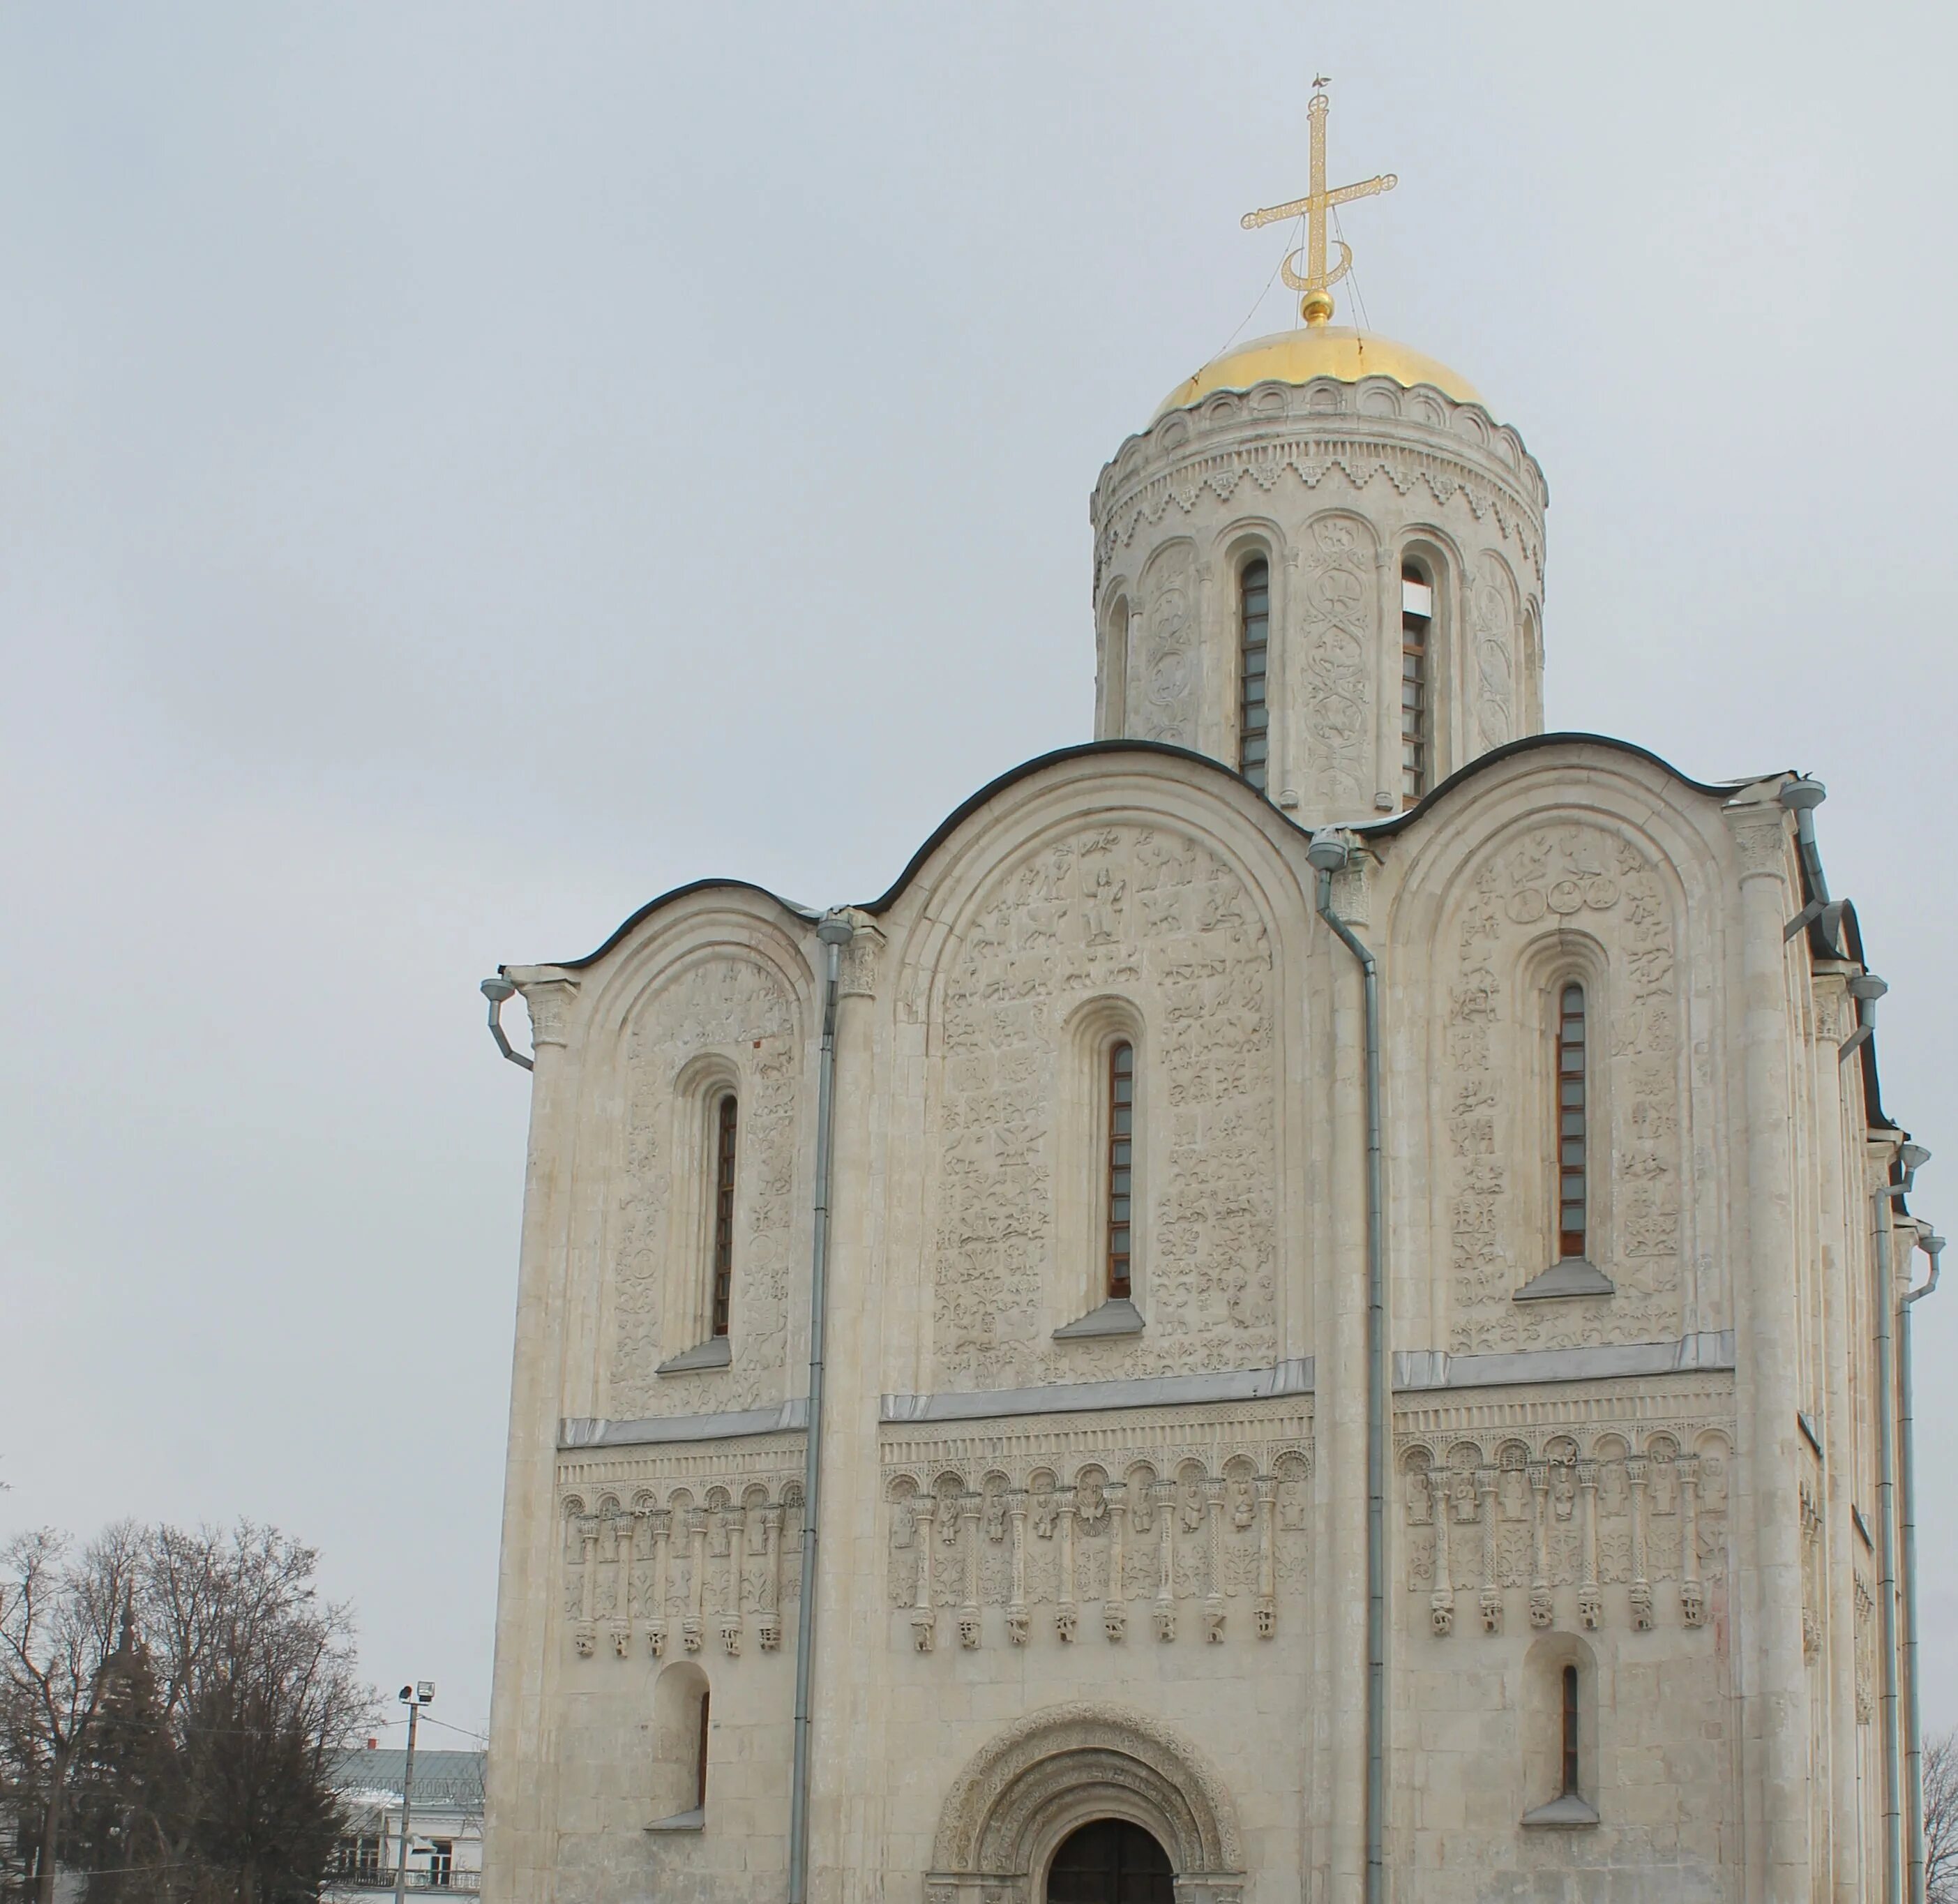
[1306,827,1390,1904]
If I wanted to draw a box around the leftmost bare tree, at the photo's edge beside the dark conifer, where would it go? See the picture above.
[0,1524,141,1904]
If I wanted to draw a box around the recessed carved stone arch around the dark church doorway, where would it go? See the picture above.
[924,1702,1245,1904]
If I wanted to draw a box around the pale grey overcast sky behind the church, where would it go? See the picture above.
[0,0,1958,1744]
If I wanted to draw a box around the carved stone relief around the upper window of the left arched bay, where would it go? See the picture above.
[611,952,801,1418]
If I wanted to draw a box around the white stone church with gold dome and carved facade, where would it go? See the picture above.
[483,100,1934,1904]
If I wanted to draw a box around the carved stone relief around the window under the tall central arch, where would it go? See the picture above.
[930,825,1277,1387]
